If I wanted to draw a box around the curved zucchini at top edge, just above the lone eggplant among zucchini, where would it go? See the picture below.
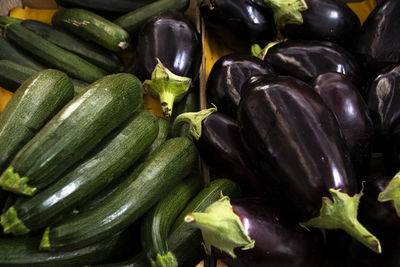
[114,0,190,34]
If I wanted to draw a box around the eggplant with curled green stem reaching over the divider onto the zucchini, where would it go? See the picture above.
[172,108,271,197]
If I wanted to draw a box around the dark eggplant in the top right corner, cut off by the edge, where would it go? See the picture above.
[354,0,400,75]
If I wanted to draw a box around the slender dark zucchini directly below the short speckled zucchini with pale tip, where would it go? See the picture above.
[21,20,122,73]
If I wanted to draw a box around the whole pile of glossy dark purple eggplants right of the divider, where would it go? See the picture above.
[173,0,400,267]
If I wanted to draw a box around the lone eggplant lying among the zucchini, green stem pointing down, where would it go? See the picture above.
[136,11,202,117]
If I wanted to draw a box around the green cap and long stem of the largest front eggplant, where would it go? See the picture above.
[300,189,382,253]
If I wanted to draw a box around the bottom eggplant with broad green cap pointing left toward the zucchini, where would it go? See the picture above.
[185,197,324,267]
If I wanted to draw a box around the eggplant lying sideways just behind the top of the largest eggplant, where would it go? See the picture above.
[265,40,361,86]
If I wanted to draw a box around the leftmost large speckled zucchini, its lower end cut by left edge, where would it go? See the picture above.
[0,69,74,172]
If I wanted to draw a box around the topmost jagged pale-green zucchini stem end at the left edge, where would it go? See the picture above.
[0,166,36,196]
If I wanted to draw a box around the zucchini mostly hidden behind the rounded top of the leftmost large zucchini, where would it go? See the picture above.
[0,59,88,95]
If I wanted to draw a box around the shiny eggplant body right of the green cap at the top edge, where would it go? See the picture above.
[281,0,361,48]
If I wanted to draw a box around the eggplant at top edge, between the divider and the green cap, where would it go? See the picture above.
[200,0,277,46]
